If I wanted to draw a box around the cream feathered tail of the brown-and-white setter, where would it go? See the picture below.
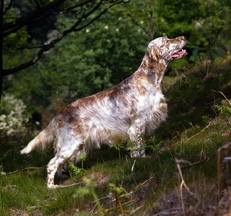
[21,124,55,154]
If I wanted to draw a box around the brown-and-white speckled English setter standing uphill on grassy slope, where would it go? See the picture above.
[21,36,187,188]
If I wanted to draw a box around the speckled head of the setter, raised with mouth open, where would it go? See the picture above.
[147,36,187,62]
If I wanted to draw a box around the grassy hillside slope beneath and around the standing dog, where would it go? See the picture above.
[0,57,231,215]
